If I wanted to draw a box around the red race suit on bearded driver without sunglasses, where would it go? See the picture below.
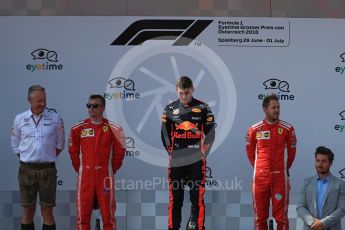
[246,120,297,230]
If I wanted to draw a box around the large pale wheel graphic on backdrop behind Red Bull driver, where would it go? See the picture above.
[105,40,237,166]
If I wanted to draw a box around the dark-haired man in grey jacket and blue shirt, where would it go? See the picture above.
[296,146,345,230]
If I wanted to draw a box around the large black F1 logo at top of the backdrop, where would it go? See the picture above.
[111,19,213,46]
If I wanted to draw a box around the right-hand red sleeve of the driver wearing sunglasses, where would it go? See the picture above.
[112,126,126,174]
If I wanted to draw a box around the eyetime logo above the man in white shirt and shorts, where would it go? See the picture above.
[26,48,63,72]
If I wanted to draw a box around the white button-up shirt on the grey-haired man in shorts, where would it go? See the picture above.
[11,109,65,163]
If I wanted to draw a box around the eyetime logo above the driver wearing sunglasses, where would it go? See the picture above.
[104,77,141,100]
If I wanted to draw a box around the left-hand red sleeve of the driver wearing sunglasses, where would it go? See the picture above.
[68,128,80,172]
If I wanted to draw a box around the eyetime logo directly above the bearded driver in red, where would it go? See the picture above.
[258,78,295,101]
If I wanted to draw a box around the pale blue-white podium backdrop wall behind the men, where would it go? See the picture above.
[0,17,345,191]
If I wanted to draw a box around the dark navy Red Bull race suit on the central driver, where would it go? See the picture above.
[161,98,216,230]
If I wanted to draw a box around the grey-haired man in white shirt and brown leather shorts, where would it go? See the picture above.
[11,85,65,230]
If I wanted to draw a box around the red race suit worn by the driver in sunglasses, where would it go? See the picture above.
[69,119,126,230]
